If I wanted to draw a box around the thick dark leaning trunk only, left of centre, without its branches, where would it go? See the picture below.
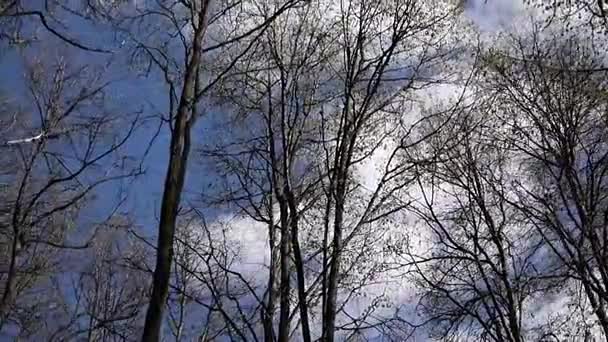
[142,0,210,342]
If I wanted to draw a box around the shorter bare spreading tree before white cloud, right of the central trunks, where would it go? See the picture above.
[404,99,556,341]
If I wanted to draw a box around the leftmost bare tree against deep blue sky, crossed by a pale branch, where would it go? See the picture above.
[0,50,138,333]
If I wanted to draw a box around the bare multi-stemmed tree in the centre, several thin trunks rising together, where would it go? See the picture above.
[189,2,466,340]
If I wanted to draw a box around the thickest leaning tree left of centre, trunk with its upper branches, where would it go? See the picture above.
[96,0,314,341]
